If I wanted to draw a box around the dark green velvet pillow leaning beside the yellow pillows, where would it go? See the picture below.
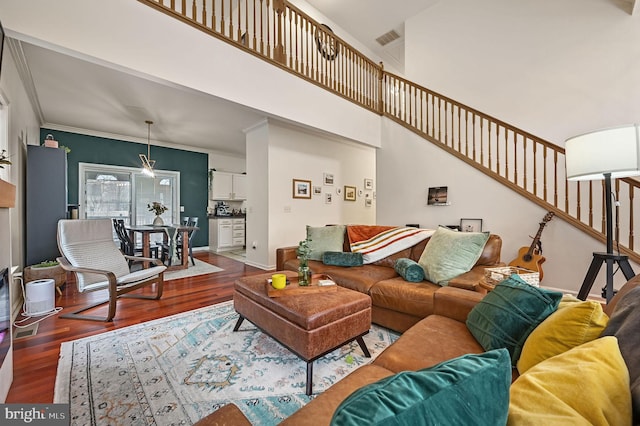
[467,274,562,366]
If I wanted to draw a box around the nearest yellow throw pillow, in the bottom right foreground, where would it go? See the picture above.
[507,336,631,426]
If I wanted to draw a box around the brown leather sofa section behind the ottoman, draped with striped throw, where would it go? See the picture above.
[276,234,503,332]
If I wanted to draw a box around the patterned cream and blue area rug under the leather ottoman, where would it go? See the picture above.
[54,302,398,425]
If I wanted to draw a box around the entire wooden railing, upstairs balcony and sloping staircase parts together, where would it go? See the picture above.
[138,0,640,263]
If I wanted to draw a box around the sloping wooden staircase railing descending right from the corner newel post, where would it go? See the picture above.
[382,72,640,262]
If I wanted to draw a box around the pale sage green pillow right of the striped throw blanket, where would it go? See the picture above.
[418,226,489,286]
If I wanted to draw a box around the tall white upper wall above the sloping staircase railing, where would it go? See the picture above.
[405,0,640,146]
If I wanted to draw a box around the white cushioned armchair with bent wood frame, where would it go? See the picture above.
[58,219,167,321]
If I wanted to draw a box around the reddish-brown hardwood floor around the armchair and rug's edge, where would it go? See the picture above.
[6,252,266,403]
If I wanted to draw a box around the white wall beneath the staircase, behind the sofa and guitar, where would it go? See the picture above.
[376,120,640,296]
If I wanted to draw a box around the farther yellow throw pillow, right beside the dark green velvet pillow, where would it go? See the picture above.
[517,298,609,374]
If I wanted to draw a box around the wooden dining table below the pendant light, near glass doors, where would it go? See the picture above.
[125,224,199,271]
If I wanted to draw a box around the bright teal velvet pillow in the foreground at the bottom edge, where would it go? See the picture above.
[331,349,511,426]
